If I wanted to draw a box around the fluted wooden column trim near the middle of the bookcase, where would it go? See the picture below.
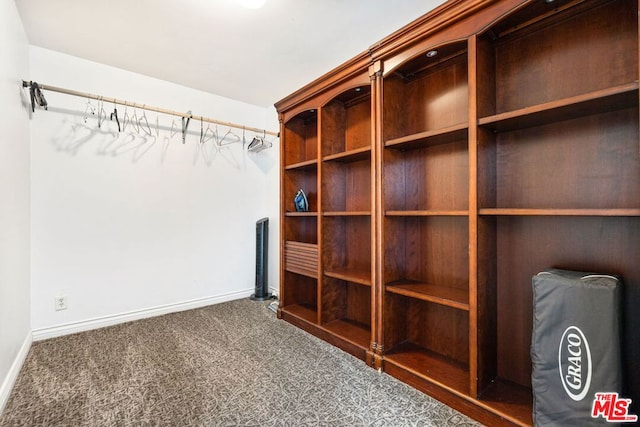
[369,61,385,369]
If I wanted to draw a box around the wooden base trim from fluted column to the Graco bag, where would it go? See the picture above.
[383,359,532,426]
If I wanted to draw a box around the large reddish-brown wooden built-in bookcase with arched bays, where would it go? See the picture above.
[276,0,640,425]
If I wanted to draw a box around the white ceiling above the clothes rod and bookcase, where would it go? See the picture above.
[15,0,444,106]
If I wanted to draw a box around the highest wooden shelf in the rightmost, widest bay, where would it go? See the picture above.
[478,81,638,132]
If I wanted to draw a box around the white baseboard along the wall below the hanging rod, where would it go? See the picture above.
[33,289,253,341]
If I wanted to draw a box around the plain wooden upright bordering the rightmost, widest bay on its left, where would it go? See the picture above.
[467,35,478,398]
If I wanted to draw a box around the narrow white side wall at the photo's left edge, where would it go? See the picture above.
[0,1,31,412]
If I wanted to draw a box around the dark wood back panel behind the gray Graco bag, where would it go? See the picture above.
[496,217,640,386]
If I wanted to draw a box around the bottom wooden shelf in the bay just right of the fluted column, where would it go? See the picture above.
[384,342,469,395]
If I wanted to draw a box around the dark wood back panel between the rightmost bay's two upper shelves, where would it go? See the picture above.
[496,108,640,209]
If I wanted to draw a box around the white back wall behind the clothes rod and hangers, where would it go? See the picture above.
[29,47,278,338]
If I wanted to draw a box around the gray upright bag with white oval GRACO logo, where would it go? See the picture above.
[531,269,622,427]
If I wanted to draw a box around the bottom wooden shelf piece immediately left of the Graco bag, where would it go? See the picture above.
[480,379,533,425]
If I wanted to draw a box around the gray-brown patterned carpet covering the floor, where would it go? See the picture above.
[0,299,476,427]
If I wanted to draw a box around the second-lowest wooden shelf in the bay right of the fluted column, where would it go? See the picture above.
[385,280,469,311]
